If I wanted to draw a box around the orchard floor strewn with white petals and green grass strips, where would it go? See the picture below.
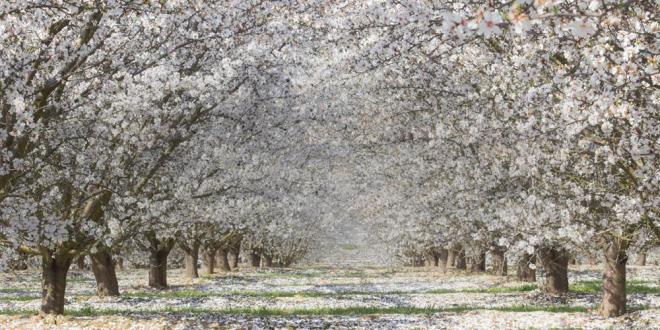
[0,266,660,329]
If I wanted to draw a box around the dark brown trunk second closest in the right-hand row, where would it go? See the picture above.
[539,248,569,293]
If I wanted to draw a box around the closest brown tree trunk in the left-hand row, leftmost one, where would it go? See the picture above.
[41,255,73,315]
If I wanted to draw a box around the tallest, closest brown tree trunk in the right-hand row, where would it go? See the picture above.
[600,238,628,317]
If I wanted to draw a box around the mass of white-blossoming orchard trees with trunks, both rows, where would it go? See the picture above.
[0,1,660,316]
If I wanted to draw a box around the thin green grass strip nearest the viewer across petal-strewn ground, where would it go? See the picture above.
[0,305,591,317]
